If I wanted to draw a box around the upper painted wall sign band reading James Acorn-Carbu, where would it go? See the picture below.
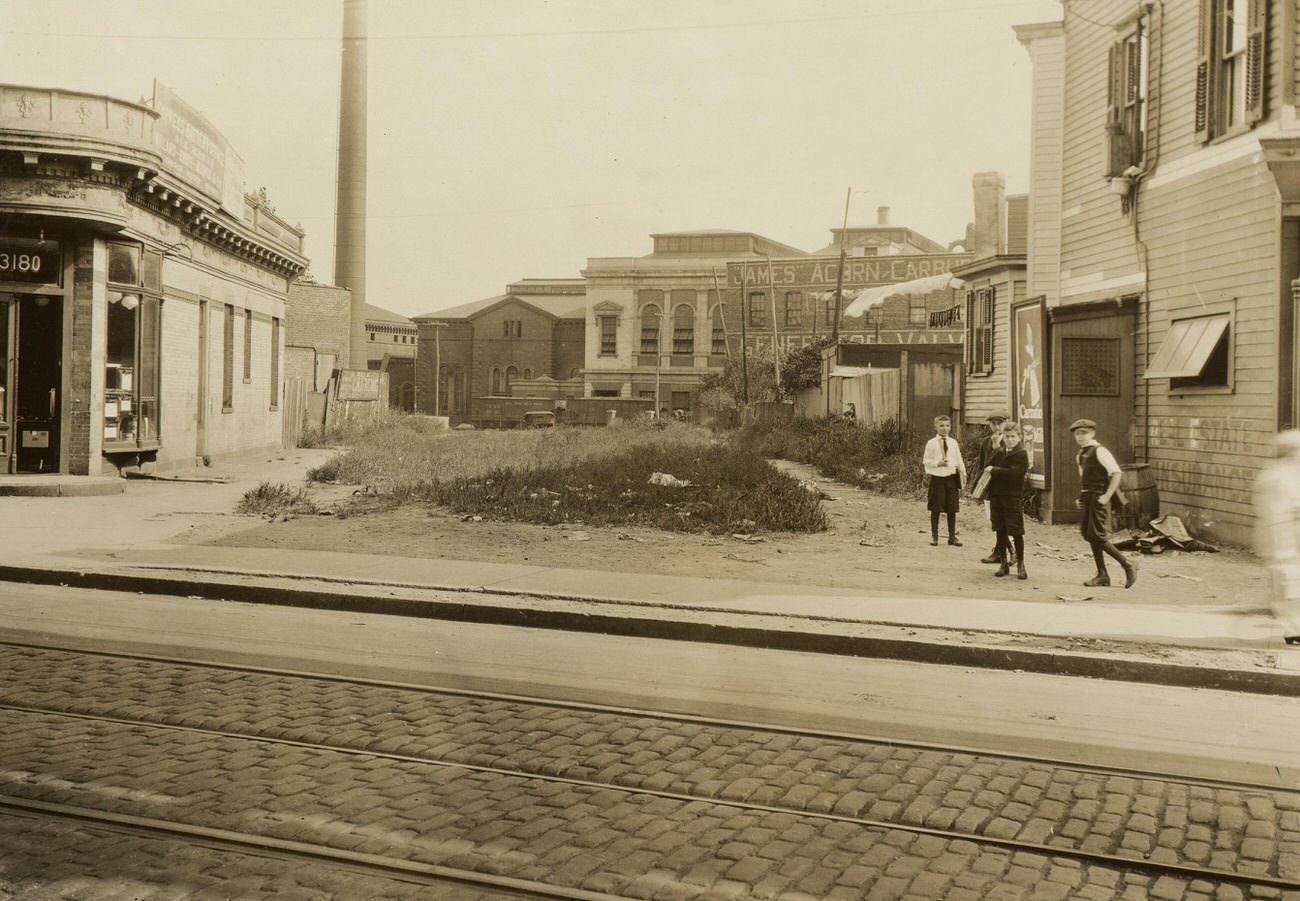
[727,254,971,289]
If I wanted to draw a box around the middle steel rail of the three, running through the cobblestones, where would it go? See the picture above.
[0,702,1300,891]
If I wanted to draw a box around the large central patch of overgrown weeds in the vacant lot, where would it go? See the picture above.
[308,420,827,533]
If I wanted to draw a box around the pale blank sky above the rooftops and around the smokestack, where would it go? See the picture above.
[0,0,1061,316]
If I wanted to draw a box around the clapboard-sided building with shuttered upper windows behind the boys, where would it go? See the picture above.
[1017,0,1300,543]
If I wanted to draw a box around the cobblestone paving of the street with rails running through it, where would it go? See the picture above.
[0,646,1300,900]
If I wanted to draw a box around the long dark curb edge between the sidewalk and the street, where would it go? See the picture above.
[0,566,1300,697]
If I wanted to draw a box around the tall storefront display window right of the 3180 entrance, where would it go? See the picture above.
[104,243,163,451]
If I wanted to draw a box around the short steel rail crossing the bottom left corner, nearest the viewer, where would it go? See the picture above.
[0,794,625,901]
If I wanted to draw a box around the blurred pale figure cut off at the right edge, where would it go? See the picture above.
[1255,429,1300,645]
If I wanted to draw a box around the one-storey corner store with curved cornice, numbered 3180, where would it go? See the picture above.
[0,85,307,475]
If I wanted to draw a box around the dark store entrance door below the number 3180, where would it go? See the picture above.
[9,294,64,472]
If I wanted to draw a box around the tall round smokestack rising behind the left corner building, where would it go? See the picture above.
[334,0,369,369]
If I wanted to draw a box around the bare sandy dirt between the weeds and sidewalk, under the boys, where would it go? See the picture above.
[202,462,1268,610]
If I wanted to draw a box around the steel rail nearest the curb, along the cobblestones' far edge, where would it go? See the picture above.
[0,631,1300,794]
